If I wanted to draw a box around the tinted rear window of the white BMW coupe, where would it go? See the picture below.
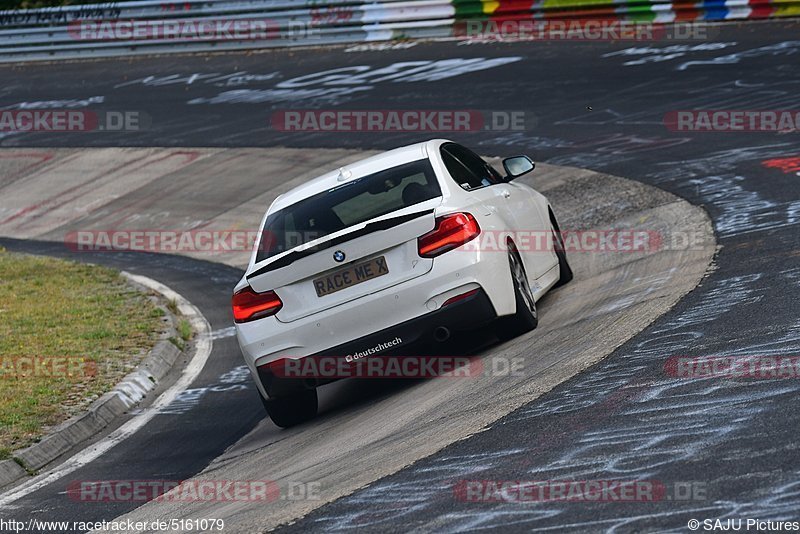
[256,158,442,262]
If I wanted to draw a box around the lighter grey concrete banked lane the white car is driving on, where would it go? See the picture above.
[0,153,715,532]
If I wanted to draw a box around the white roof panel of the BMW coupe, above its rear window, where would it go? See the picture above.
[269,139,447,213]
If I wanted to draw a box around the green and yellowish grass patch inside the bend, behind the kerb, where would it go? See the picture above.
[0,249,164,459]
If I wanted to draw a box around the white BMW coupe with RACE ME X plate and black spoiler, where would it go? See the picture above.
[233,139,572,427]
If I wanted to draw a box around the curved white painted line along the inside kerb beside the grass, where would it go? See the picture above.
[0,271,213,506]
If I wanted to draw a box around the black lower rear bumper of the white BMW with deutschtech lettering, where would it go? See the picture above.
[257,289,497,397]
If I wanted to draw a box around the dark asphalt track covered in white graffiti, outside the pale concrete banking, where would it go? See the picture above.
[0,16,800,532]
